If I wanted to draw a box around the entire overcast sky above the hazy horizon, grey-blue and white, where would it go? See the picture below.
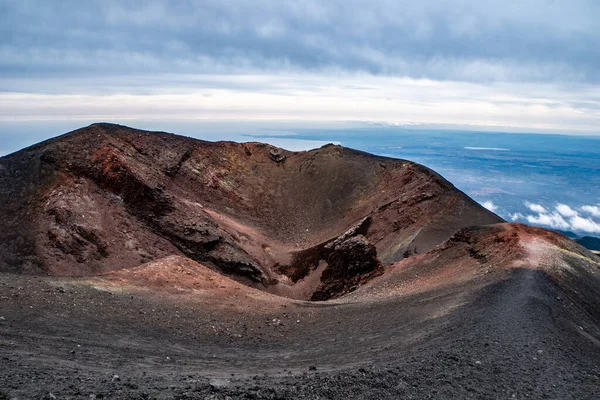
[0,0,600,134]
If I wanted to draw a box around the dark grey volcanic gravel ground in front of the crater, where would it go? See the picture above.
[0,269,600,399]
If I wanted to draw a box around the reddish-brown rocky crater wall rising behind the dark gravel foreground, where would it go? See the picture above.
[0,124,501,300]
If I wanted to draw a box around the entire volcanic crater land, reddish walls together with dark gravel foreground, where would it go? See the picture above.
[0,124,600,399]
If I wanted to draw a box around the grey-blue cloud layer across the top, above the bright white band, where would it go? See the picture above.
[0,0,600,82]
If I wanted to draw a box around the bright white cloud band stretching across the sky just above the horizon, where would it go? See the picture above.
[0,75,600,136]
